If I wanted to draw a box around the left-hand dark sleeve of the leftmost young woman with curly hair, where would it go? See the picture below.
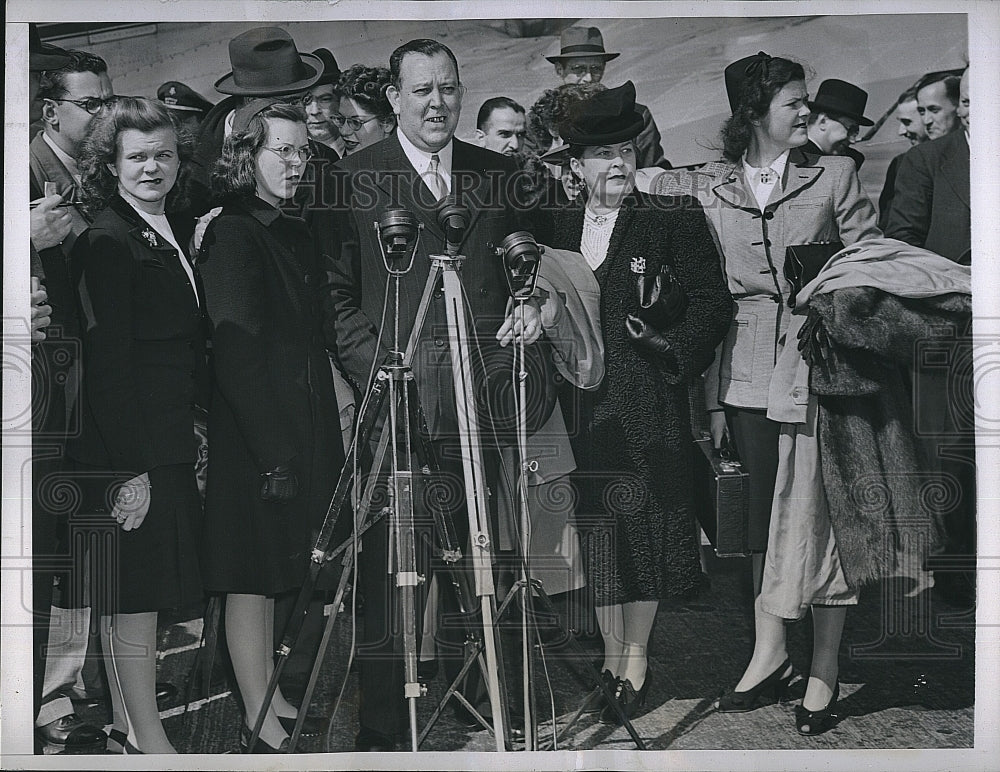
[73,226,157,473]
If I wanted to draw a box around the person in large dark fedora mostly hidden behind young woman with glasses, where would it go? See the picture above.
[186,27,325,215]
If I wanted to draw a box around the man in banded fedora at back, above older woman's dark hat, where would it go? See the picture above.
[545,27,671,169]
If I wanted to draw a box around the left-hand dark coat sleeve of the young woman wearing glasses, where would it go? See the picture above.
[201,216,296,472]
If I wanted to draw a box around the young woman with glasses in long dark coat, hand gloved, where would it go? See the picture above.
[200,100,344,752]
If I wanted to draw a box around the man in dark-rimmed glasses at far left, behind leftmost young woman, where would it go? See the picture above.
[28,43,113,749]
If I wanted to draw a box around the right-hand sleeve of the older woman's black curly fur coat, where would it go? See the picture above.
[664,197,733,383]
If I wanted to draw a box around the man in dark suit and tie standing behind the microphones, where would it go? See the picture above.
[320,40,547,750]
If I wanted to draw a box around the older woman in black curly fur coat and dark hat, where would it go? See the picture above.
[546,82,732,723]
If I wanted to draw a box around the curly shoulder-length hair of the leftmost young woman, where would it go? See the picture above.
[78,97,193,216]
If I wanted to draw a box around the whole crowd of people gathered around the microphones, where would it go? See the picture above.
[29,19,976,753]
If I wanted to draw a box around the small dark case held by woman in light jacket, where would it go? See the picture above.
[694,434,750,558]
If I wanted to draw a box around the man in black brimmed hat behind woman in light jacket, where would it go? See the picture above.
[802,78,874,169]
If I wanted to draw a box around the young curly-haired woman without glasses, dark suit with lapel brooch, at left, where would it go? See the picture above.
[68,97,208,753]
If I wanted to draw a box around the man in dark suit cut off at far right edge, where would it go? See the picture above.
[885,68,976,607]
